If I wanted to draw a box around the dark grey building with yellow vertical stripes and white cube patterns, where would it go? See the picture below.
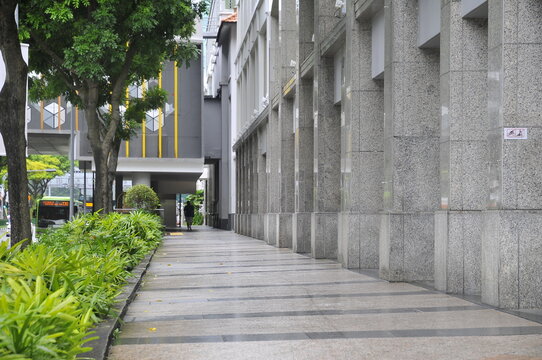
[27,54,204,227]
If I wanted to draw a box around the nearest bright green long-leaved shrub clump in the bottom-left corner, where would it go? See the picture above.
[0,276,91,360]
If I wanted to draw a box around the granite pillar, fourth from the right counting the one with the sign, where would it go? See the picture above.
[339,1,384,269]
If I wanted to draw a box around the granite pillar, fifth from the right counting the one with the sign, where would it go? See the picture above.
[311,0,341,259]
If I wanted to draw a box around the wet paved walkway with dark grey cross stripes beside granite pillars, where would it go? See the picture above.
[109,229,542,360]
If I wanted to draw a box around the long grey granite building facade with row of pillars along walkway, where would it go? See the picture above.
[229,0,542,308]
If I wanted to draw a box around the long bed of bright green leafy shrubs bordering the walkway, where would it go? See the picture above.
[0,212,162,360]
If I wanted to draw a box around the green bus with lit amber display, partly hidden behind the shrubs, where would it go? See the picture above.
[36,196,83,233]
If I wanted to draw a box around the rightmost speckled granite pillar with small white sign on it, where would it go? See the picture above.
[482,0,542,309]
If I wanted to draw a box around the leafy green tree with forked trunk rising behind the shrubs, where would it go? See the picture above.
[20,0,206,212]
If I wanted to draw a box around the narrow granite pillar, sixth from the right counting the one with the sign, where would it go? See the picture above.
[292,0,314,253]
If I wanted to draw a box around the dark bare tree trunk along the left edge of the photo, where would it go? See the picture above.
[0,0,32,245]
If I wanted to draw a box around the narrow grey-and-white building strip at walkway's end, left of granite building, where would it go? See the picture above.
[203,0,237,230]
